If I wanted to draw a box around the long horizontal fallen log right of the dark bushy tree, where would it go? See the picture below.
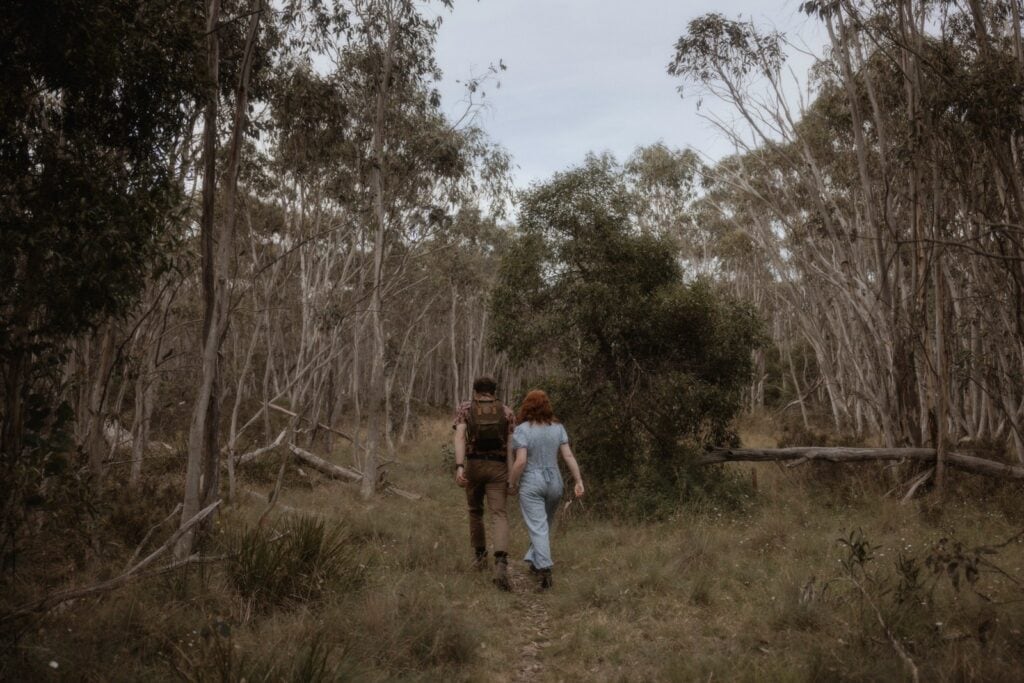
[696,445,1024,479]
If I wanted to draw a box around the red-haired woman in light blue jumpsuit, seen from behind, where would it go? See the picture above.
[509,389,584,590]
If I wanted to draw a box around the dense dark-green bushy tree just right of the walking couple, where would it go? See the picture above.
[492,157,761,518]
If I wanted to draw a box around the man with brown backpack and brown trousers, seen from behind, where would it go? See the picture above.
[452,377,515,591]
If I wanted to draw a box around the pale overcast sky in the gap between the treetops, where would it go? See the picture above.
[437,0,822,185]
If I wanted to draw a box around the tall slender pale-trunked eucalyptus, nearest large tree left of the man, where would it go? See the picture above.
[323,0,503,496]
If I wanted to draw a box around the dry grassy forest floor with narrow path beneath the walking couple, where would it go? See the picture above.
[6,413,1024,681]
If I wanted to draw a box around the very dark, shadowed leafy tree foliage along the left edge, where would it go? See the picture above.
[0,0,202,462]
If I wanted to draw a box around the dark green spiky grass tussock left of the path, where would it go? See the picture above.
[227,515,366,608]
